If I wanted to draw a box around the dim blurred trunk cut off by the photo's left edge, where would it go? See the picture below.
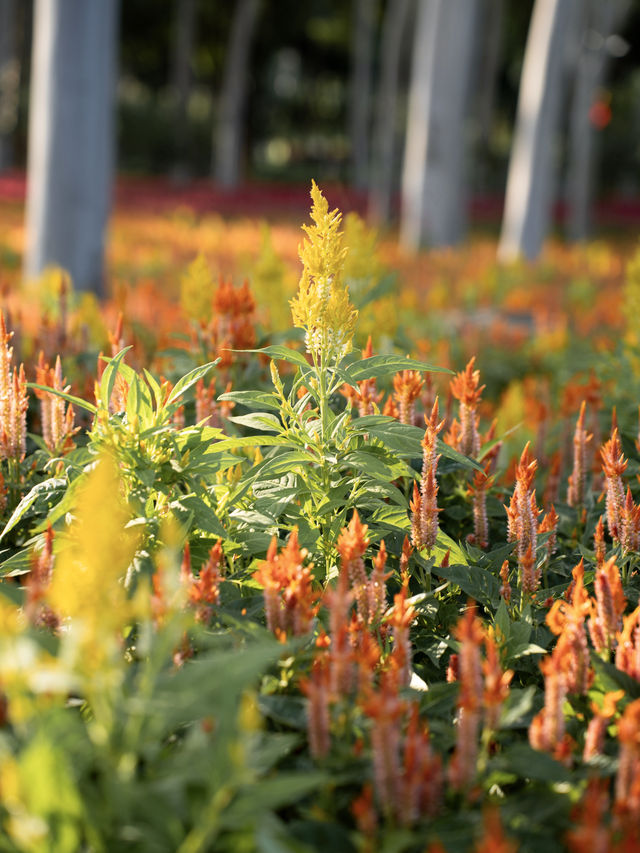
[0,0,20,172]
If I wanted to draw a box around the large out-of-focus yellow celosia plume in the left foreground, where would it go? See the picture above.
[48,455,138,673]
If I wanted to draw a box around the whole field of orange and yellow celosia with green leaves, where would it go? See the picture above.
[0,185,640,853]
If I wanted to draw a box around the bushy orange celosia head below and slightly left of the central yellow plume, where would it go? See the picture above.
[253,528,318,640]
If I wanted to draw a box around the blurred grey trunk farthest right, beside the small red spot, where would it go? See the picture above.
[566,0,630,241]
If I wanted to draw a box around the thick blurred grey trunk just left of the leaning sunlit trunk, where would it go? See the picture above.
[400,0,477,250]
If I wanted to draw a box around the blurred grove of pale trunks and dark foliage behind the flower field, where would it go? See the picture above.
[0,0,640,293]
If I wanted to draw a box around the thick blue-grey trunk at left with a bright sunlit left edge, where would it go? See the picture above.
[25,0,118,293]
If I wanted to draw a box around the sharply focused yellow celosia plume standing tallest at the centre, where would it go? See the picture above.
[291,181,358,360]
